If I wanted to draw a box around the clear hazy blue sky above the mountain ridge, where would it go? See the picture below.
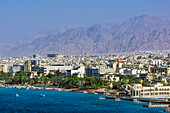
[0,0,170,43]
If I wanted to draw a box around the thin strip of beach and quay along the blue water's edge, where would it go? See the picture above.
[0,84,170,105]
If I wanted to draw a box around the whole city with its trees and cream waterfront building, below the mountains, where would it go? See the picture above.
[0,51,170,97]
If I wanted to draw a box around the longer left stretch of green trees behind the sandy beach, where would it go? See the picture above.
[0,71,109,89]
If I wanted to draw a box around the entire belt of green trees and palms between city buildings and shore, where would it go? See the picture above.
[0,71,167,89]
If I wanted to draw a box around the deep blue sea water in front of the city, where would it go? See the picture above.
[0,88,166,113]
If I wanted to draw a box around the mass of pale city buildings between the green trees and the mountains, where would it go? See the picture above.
[0,52,170,84]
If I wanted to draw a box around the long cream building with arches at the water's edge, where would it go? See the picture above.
[130,83,170,98]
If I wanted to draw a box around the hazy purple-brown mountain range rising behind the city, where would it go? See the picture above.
[0,15,170,57]
